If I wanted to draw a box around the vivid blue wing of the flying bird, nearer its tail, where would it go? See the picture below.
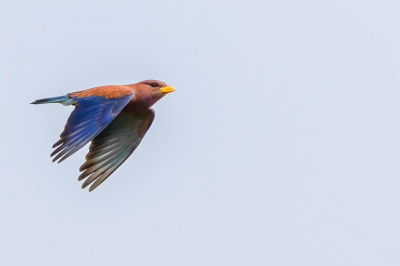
[51,92,135,163]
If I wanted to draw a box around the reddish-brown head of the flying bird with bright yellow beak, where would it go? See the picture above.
[135,79,175,107]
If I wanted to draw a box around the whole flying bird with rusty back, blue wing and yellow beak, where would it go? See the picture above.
[31,80,175,192]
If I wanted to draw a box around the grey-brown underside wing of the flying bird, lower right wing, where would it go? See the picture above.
[78,106,154,191]
